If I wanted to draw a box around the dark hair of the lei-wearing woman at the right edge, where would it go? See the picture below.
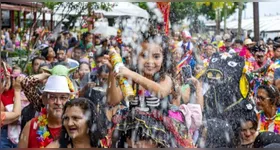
[258,85,280,106]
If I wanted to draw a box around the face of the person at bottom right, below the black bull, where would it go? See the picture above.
[241,121,256,144]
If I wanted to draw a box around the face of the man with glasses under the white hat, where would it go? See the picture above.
[43,93,70,119]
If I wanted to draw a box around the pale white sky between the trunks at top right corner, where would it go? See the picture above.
[230,1,280,19]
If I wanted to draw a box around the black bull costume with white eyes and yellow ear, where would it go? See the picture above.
[204,53,249,119]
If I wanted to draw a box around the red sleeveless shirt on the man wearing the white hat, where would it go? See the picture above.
[28,117,61,148]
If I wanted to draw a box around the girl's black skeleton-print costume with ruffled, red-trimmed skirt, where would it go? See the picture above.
[112,86,193,148]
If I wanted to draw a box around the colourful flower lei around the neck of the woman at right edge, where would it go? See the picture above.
[260,107,280,134]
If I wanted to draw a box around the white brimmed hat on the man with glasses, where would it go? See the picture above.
[43,75,70,93]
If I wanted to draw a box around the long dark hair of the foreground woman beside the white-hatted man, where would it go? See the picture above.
[59,98,107,148]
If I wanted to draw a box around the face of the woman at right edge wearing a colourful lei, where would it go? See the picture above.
[257,89,272,110]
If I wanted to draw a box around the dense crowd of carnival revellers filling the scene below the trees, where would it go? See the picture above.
[0,22,280,148]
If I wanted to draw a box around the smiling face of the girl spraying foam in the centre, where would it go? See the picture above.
[138,43,163,76]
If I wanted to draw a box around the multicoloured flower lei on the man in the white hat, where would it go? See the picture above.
[36,108,53,148]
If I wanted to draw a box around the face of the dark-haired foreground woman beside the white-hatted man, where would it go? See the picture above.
[63,106,88,139]
